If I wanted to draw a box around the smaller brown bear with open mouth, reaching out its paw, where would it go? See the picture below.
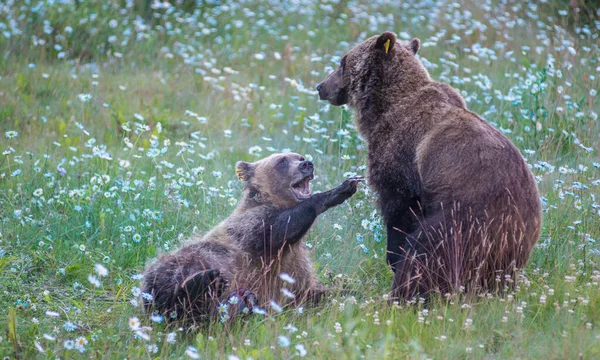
[142,153,361,319]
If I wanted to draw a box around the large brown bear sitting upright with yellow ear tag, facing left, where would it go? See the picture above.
[317,32,541,299]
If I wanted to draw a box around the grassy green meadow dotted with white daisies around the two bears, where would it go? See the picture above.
[0,0,600,360]
